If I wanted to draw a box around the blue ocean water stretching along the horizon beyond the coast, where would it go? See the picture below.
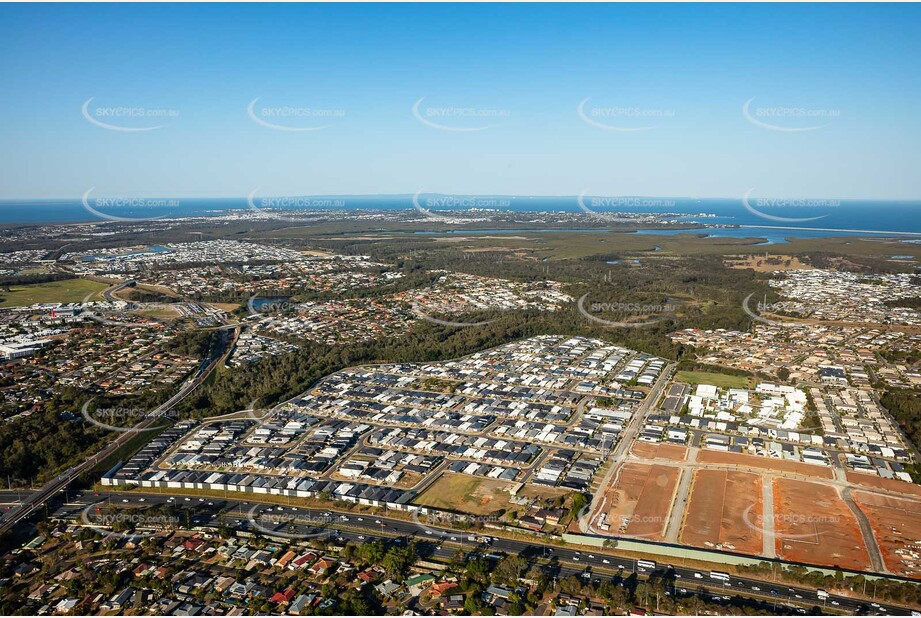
[0,194,921,242]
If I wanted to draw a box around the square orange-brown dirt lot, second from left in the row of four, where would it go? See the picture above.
[679,470,763,554]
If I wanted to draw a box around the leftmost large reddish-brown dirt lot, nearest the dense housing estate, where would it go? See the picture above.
[604,462,679,540]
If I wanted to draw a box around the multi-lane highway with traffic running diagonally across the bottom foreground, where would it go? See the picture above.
[55,491,911,615]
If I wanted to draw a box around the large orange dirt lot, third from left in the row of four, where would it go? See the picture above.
[774,478,871,570]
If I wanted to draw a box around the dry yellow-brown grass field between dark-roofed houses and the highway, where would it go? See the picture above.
[416,472,511,515]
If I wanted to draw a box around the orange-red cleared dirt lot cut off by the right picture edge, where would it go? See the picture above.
[853,491,921,579]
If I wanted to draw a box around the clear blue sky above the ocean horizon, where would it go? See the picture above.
[0,4,921,199]
